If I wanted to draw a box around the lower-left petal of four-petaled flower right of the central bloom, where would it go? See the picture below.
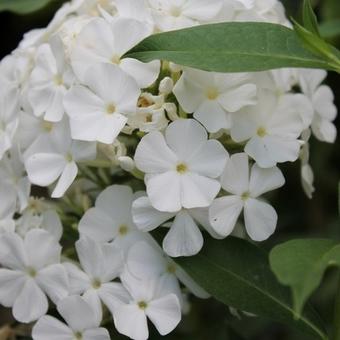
[209,196,243,237]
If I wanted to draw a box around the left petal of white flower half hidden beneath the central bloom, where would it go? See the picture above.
[132,196,174,231]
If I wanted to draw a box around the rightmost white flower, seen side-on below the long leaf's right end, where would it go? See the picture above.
[299,70,337,143]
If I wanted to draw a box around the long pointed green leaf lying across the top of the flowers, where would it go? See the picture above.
[125,22,332,72]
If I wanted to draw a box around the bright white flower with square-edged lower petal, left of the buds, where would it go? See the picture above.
[64,64,140,144]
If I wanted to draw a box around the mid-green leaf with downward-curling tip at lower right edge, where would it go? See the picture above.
[270,239,340,315]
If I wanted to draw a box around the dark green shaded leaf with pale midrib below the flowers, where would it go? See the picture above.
[171,237,326,339]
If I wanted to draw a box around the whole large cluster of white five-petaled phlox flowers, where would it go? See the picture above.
[0,0,337,340]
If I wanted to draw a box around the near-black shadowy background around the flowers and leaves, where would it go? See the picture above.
[0,0,340,340]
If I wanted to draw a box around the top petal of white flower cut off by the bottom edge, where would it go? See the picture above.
[57,295,99,332]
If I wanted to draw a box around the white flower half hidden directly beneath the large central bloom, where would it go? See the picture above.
[132,196,222,257]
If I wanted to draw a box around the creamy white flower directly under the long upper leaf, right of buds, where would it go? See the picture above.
[173,69,256,132]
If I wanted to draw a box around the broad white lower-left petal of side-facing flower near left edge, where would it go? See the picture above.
[25,153,66,186]
